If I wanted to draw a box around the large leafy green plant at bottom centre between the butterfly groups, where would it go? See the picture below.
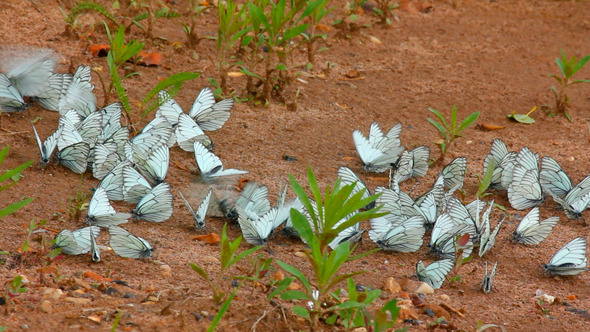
[269,169,385,329]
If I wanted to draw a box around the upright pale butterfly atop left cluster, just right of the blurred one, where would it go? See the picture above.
[58,66,96,117]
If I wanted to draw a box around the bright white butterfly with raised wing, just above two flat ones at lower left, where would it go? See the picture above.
[86,186,131,227]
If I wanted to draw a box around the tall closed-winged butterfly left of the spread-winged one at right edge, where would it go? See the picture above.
[508,147,544,210]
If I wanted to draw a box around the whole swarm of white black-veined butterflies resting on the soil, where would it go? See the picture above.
[0,53,590,293]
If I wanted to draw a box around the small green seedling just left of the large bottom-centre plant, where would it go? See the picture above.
[190,224,262,303]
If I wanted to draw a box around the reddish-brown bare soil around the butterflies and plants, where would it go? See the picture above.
[0,0,590,331]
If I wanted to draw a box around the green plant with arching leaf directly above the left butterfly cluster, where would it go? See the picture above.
[105,24,199,124]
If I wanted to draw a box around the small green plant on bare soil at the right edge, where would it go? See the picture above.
[549,50,590,122]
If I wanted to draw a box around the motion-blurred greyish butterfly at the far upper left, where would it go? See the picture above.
[6,50,56,97]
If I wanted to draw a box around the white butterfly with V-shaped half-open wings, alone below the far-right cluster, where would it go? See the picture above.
[512,207,559,245]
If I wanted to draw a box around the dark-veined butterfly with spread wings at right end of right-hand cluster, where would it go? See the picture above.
[540,157,590,219]
